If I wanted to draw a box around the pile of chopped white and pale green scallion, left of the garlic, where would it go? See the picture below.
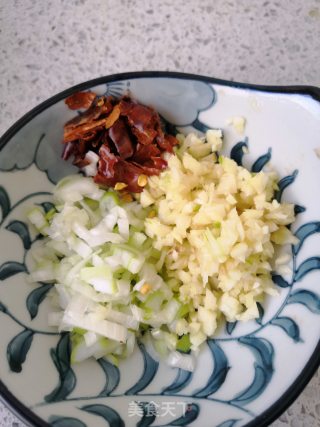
[29,176,176,362]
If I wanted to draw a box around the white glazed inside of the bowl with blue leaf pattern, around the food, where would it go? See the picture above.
[0,73,320,427]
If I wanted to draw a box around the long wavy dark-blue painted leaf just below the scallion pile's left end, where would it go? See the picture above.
[44,334,76,402]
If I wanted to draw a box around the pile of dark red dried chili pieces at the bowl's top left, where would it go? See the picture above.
[62,92,178,192]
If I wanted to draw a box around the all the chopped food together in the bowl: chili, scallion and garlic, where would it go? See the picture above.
[29,92,296,371]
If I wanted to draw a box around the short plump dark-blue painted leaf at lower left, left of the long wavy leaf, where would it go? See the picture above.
[7,329,33,372]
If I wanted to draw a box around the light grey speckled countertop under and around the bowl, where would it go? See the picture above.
[0,0,320,427]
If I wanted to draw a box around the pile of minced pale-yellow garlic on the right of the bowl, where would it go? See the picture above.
[139,130,297,347]
